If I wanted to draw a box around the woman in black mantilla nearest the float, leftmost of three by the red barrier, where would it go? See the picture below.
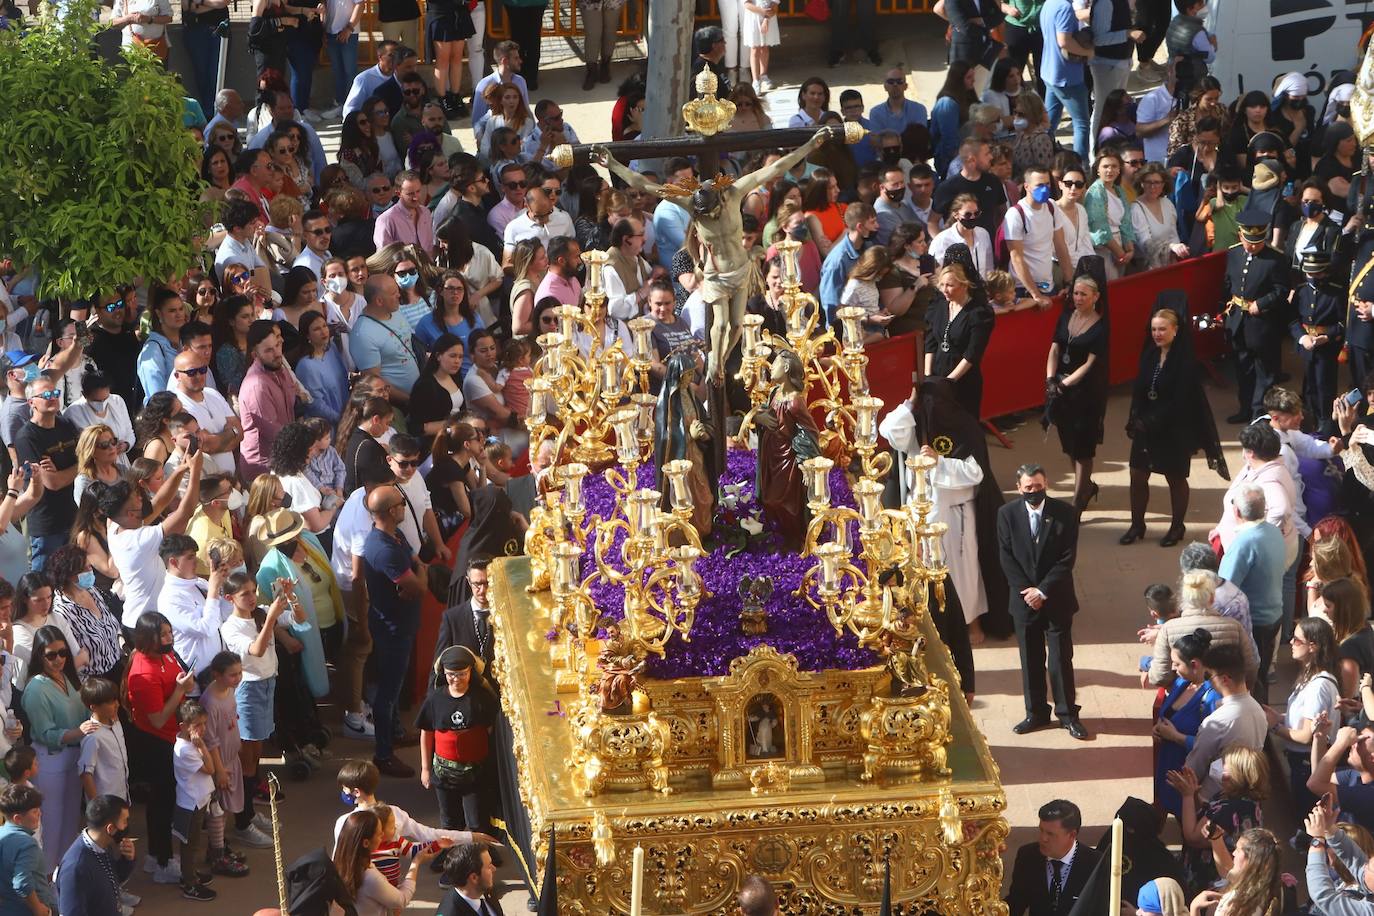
[926,244,993,420]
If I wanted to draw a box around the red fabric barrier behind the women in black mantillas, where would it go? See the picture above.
[864,253,1226,417]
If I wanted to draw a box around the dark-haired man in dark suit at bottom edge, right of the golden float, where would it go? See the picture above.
[1007,798,1101,916]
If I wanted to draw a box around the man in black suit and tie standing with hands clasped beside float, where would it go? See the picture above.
[998,464,1088,740]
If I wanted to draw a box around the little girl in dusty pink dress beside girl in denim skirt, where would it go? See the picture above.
[201,651,249,878]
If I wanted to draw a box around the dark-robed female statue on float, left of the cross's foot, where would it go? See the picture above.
[654,350,720,537]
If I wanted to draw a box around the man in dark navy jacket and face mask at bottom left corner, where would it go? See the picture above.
[58,795,135,915]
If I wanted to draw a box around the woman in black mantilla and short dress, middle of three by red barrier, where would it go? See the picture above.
[1041,255,1110,512]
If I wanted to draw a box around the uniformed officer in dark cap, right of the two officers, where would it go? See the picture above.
[1289,250,1347,435]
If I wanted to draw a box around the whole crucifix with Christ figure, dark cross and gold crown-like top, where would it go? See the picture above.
[554,77,863,494]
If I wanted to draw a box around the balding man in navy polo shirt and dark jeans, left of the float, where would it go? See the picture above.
[363,486,425,779]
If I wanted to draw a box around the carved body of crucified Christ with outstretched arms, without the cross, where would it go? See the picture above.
[591,128,838,385]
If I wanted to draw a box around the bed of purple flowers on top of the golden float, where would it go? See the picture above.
[571,449,881,680]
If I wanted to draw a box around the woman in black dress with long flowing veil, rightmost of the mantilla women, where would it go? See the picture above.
[1121,290,1231,547]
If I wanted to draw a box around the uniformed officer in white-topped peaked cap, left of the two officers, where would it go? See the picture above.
[1221,206,1290,423]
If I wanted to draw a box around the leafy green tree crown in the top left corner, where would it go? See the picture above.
[0,0,203,299]
